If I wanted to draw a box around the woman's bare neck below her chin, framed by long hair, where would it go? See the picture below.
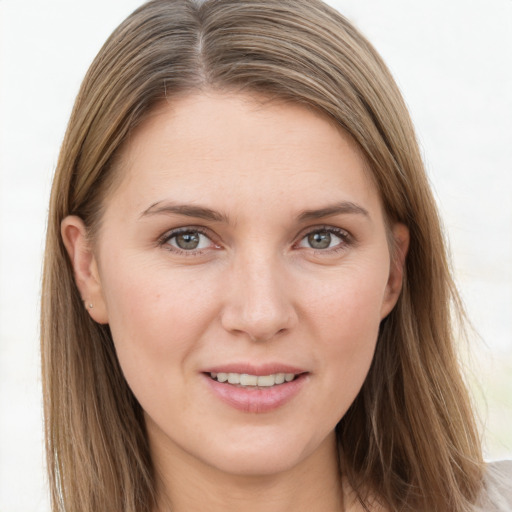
[152,433,344,512]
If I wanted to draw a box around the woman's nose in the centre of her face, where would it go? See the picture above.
[221,254,298,341]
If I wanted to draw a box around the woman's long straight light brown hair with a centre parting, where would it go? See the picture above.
[41,0,482,512]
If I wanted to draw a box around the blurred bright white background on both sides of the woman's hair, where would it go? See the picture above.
[0,0,512,512]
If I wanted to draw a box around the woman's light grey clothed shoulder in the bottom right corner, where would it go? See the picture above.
[475,460,512,512]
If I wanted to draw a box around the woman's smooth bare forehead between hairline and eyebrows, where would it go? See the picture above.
[107,92,380,219]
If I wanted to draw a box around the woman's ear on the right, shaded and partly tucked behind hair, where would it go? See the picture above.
[381,222,410,319]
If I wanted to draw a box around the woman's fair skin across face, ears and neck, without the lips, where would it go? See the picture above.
[62,92,408,512]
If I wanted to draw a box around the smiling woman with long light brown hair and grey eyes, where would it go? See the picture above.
[42,0,510,512]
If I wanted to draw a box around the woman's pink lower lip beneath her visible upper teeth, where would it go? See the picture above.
[203,373,308,413]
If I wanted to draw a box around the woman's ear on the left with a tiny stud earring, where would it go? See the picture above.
[60,215,108,324]
